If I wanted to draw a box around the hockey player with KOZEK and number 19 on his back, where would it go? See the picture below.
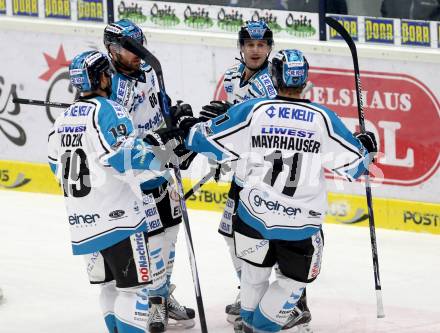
[48,51,185,333]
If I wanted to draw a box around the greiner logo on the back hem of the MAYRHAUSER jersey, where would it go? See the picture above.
[249,189,301,218]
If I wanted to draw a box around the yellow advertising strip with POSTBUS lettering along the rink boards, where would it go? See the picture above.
[0,161,440,234]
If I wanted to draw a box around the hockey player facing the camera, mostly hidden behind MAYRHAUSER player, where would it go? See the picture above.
[218,20,311,329]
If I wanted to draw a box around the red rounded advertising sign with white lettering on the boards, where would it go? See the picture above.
[306,67,440,186]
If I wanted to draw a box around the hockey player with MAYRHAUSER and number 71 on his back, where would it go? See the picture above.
[175,50,377,333]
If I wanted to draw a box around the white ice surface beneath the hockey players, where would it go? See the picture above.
[0,191,440,333]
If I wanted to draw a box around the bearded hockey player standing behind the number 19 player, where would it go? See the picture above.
[104,19,195,333]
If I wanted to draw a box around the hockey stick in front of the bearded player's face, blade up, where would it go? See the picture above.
[121,37,208,333]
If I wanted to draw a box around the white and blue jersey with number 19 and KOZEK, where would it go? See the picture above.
[48,97,165,254]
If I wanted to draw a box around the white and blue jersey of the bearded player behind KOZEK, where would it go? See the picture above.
[110,63,170,189]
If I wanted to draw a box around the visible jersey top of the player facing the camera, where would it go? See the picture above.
[223,63,277,104]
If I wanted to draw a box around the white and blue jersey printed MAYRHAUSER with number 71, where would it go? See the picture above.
[186,97,368,240]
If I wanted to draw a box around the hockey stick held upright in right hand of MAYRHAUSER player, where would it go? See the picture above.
[325,17,385,318]
